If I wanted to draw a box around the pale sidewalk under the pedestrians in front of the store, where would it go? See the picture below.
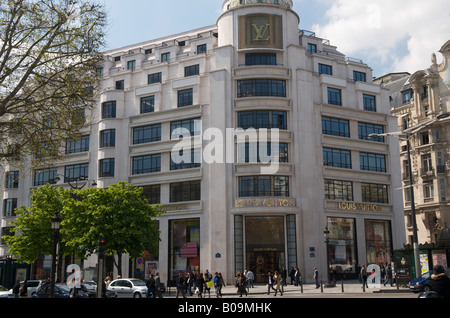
[165,280,412,298]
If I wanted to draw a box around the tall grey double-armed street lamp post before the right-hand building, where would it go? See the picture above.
[369,113,450,277]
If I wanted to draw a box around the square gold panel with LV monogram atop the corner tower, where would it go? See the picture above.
[239,14,283,49]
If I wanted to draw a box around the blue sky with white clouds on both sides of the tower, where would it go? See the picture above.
[103,0,450,76]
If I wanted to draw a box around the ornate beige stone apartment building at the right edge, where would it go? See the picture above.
[376,41,450,244]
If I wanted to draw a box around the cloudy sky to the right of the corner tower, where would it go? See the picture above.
[313,0,450,75]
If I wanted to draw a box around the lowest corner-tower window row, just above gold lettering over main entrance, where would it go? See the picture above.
[239,176,289,197]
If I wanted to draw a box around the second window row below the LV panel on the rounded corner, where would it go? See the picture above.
[237,79,286,98]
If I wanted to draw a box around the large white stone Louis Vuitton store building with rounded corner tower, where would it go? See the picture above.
[0,0,405,282]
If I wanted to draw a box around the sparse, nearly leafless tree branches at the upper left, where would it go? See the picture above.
[0,0,107,166]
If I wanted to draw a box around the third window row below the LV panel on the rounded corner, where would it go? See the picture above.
[238,110,287,130]
